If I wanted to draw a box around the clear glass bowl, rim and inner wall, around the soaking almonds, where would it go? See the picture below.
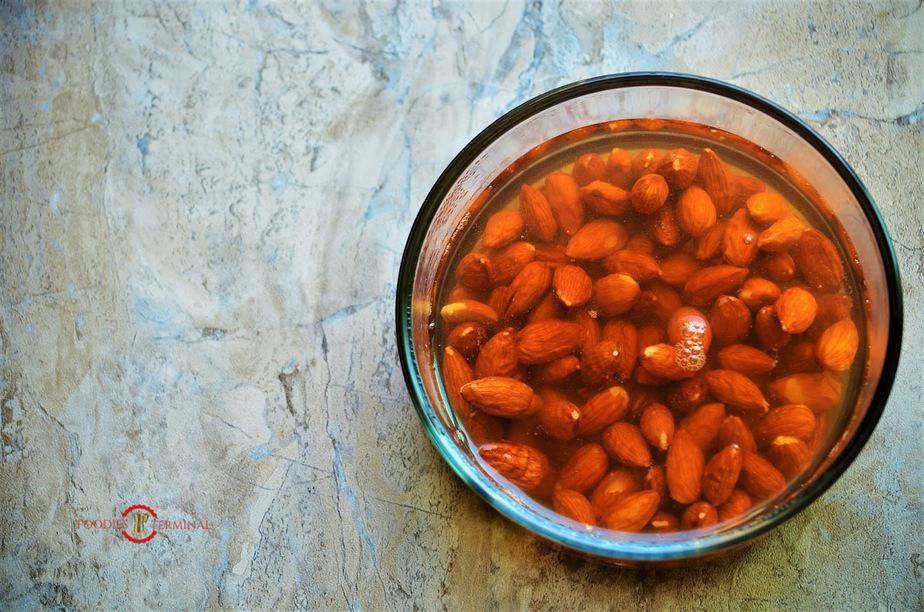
[396,73,902,565]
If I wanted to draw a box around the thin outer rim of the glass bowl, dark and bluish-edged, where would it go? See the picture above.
[395,72,903,561]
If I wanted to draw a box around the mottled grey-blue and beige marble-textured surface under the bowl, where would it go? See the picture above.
[0,0,924,610]
